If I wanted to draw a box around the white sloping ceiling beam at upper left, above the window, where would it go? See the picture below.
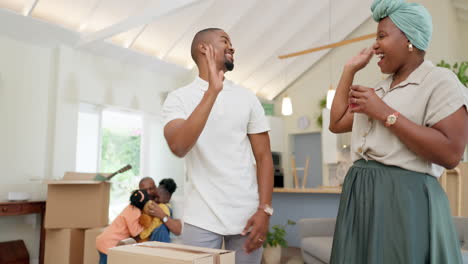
[76,0,200,47]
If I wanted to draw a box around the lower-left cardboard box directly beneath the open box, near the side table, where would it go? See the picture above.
[44,229,85,264]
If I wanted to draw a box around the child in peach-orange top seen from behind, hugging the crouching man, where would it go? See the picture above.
[96,190,149,264]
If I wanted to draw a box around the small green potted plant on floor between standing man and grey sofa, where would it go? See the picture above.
[263,220,296,264]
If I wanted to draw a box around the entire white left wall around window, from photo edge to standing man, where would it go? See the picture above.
[0,36,190,263]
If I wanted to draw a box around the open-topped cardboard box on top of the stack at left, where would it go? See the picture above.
[44,172,110,228]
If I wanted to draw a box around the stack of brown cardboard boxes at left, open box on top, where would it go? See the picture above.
[44,172,110,264]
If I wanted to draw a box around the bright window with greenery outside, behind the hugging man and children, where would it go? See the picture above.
[76,104,143,221]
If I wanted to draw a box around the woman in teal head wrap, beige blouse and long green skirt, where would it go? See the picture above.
[330,0,468,264]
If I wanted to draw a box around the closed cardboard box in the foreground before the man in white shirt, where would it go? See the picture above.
[107,242,235,264]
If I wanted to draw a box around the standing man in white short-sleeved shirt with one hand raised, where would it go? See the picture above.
[163,28,273,264]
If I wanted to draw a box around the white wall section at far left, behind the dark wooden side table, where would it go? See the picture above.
[0,36,52,259]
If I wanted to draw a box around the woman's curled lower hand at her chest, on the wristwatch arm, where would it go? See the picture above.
[348,85,392,120]
